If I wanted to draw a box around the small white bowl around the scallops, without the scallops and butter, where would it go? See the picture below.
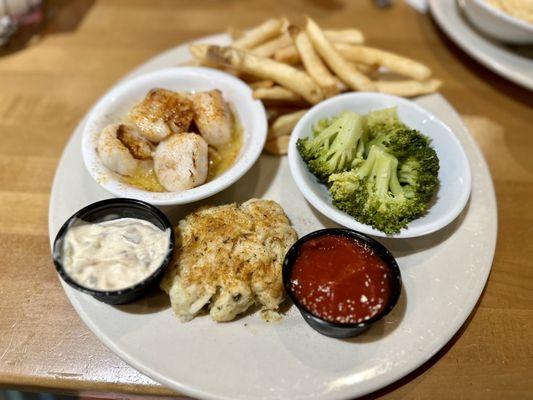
[82,67,267,205]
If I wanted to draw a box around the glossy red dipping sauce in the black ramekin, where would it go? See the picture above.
[290,235,393,324]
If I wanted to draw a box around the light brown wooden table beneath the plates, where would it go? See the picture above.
[0,0,533,399]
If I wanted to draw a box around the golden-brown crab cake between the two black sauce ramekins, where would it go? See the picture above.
[161,199,298,321]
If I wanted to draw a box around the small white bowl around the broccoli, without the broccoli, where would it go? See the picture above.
[289,92,471,239]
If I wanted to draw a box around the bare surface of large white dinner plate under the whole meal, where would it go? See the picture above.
[49,36,497,400]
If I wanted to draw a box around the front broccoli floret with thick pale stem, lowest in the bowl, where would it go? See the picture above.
[329,137,438,234]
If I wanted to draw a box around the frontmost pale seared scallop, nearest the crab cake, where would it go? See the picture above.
[154,133,208,192]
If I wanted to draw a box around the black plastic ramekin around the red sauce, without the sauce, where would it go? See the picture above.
[282,228,402,338]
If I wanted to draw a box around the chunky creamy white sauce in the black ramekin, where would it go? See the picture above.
[63,218,170,290]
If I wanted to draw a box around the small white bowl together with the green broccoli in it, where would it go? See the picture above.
[289,93,471,238]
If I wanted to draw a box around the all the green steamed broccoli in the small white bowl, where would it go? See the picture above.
[298,108,439,234]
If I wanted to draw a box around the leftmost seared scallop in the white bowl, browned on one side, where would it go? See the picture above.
[97,124,154,175]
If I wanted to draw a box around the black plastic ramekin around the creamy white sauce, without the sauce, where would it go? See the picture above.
[52,198,174,304]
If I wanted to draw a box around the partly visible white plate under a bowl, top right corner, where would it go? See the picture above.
[429,0,533,90]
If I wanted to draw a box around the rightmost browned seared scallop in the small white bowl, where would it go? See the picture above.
[193,90,232,147]
